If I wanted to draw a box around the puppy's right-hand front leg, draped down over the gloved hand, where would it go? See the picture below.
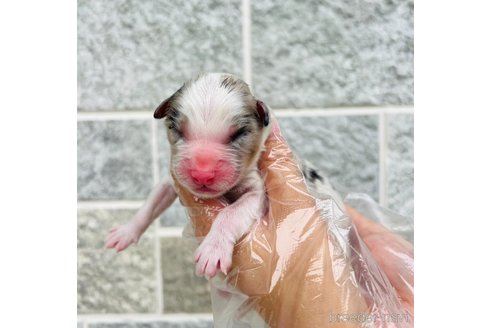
[195,179,265,278]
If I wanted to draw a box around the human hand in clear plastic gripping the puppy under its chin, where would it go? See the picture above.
[175,121,367,327]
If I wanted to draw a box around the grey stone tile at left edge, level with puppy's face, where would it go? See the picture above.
[77,121,153,200]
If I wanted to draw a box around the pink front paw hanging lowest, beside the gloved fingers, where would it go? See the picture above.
[195,233,234,279]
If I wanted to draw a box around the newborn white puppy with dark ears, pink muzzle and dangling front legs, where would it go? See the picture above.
[106,73,270,278]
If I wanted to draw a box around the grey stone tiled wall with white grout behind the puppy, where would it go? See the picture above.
[77,0,413,328]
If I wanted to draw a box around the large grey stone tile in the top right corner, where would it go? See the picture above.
[252,0,413,108]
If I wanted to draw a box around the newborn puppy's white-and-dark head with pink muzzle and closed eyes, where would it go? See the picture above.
[154,73,270,198]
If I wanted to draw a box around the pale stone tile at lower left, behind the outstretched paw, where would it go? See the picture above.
[77,210,157,314]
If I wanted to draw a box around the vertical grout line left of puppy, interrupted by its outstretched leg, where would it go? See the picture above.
[150,120,164,314]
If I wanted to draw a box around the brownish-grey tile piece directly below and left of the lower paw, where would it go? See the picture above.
[161,238,212,313]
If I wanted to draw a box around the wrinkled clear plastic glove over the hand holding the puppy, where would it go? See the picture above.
[178,123,413,328]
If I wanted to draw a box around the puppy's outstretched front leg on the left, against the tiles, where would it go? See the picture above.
[106,180,177,252]
